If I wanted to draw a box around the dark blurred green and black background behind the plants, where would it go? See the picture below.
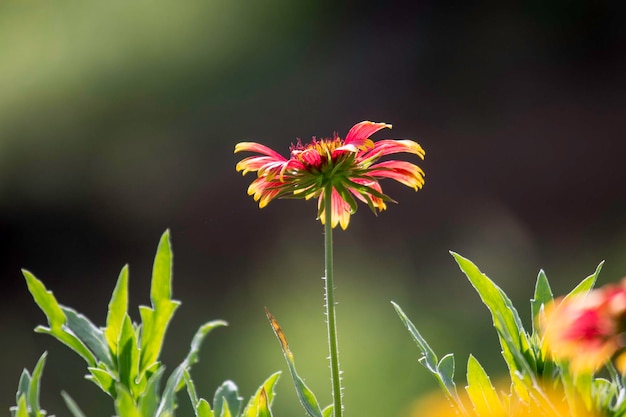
[0,0,626,416]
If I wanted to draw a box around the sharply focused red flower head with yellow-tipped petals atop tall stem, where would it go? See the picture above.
[235,121,424,229]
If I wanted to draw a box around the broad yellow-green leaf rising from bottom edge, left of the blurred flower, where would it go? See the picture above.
[465,354,505,416]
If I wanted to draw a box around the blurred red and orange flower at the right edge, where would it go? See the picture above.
[540,280,626,374]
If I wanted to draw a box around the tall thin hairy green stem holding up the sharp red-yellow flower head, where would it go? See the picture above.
[324,185,343,417]
